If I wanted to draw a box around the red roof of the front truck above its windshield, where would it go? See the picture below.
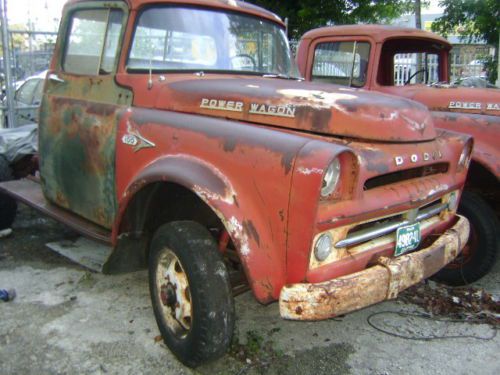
[66,0,285,27]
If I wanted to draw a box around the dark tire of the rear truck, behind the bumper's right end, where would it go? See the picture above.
[435,191,500,285]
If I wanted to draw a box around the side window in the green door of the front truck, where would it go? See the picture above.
[63,9,123,75]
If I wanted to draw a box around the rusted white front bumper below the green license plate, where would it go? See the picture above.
[280,216,469,320]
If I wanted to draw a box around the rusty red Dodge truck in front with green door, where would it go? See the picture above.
[0,0,473,366]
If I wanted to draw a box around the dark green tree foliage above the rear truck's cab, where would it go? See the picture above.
[249,0,413,39]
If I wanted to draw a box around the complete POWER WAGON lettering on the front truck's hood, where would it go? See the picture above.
[200,98,296,118]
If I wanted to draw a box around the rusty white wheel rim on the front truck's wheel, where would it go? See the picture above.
[156,248,192,338]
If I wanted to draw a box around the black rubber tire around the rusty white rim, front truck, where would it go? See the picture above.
[149,221,235,367]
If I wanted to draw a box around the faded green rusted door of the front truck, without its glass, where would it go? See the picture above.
[39,2,132,228]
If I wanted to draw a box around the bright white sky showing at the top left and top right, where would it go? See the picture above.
[7,0,446,31]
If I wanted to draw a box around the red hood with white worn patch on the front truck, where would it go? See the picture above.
[154,75,436,142]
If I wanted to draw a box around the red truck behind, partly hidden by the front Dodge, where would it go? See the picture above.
[297,25,500,285]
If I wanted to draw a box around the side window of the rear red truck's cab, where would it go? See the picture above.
[312,41,370,87]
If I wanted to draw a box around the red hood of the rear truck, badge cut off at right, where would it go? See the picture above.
[384,85,500,116]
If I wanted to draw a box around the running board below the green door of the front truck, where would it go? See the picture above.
[0,178,111,245]
